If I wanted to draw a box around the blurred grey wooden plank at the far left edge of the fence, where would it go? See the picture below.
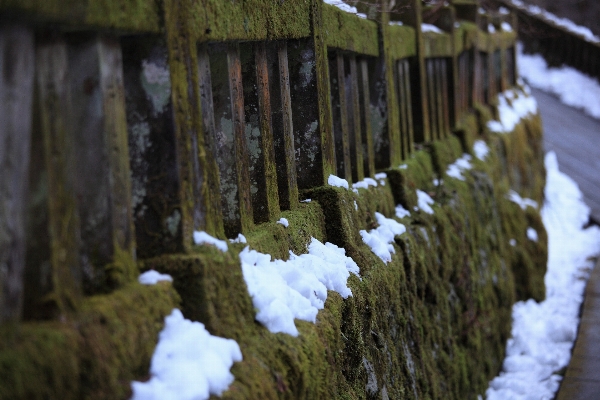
[0,23,35,324]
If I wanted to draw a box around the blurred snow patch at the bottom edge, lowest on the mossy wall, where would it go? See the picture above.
[131,309,242,400]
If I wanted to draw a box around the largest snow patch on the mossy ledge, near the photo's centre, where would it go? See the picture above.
[240,238,359,336]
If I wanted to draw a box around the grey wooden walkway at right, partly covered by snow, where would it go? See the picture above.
[533,90,600,400]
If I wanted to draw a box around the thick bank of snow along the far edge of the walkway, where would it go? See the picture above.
[517,45,600,118]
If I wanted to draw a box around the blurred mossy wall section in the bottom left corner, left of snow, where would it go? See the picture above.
[0,283,179,400]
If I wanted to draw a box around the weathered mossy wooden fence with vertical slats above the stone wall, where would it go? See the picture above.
[0,0,516,321]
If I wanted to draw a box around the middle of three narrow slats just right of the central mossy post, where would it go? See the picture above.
[346,54,365,181]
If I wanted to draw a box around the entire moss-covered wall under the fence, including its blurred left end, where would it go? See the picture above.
[0,106,547,399]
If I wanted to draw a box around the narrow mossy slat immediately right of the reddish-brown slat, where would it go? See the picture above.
[254,42,279,222]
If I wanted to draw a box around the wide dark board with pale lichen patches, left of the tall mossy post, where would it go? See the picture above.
[121,35,185,258]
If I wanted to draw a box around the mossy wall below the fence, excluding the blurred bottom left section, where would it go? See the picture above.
[142,112,547,399]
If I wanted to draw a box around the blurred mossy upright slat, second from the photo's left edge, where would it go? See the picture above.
[23,32,82,319]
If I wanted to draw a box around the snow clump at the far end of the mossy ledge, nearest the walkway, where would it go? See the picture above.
[487,87,537,133]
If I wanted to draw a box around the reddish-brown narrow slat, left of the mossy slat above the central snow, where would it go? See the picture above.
[227,43,253,233]
